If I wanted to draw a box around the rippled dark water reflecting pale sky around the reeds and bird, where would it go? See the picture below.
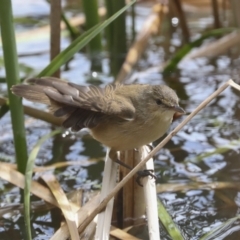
[0,1,240,239]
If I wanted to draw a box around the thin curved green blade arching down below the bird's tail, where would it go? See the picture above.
[24,130,62,240]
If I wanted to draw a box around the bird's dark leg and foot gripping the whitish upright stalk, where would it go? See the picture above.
[109,149,157,187]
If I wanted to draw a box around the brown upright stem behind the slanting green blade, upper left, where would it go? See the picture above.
[50,0,62,77]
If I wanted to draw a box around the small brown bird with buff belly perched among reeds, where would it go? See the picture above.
[12,77,185,169]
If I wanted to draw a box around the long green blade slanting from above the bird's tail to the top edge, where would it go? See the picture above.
[38,0,136,77]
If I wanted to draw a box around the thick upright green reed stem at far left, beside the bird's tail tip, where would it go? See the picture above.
[0,0,27,173]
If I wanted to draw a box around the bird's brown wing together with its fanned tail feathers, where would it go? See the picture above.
[12,77,135,131]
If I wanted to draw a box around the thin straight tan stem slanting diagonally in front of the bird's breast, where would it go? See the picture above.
[78,79,235,232]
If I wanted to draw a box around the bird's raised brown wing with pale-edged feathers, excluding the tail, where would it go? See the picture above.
[28,78,135,120]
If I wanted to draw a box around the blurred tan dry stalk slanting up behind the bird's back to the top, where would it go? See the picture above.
[115,4,168,82]
